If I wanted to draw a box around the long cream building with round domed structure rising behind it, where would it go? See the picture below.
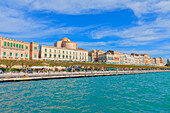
[39,38,88,61]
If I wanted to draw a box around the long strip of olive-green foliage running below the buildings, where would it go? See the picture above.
[0,59,170,71]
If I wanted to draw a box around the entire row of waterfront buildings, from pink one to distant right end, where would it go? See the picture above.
[0,36,166,66]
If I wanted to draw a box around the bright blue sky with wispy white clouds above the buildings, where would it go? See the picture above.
[0,0,170,61]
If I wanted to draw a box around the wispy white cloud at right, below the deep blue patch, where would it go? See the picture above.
[91,16,170,43]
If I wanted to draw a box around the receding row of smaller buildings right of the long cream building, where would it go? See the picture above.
[89,50,166,66]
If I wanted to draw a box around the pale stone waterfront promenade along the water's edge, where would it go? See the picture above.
[0,70,170,82]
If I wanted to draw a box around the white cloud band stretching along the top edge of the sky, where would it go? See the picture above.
[3,0,170,17]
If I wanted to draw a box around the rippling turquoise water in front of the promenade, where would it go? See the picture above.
[0,72,170,113]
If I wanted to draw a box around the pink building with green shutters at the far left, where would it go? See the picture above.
[0,36,39,60]
